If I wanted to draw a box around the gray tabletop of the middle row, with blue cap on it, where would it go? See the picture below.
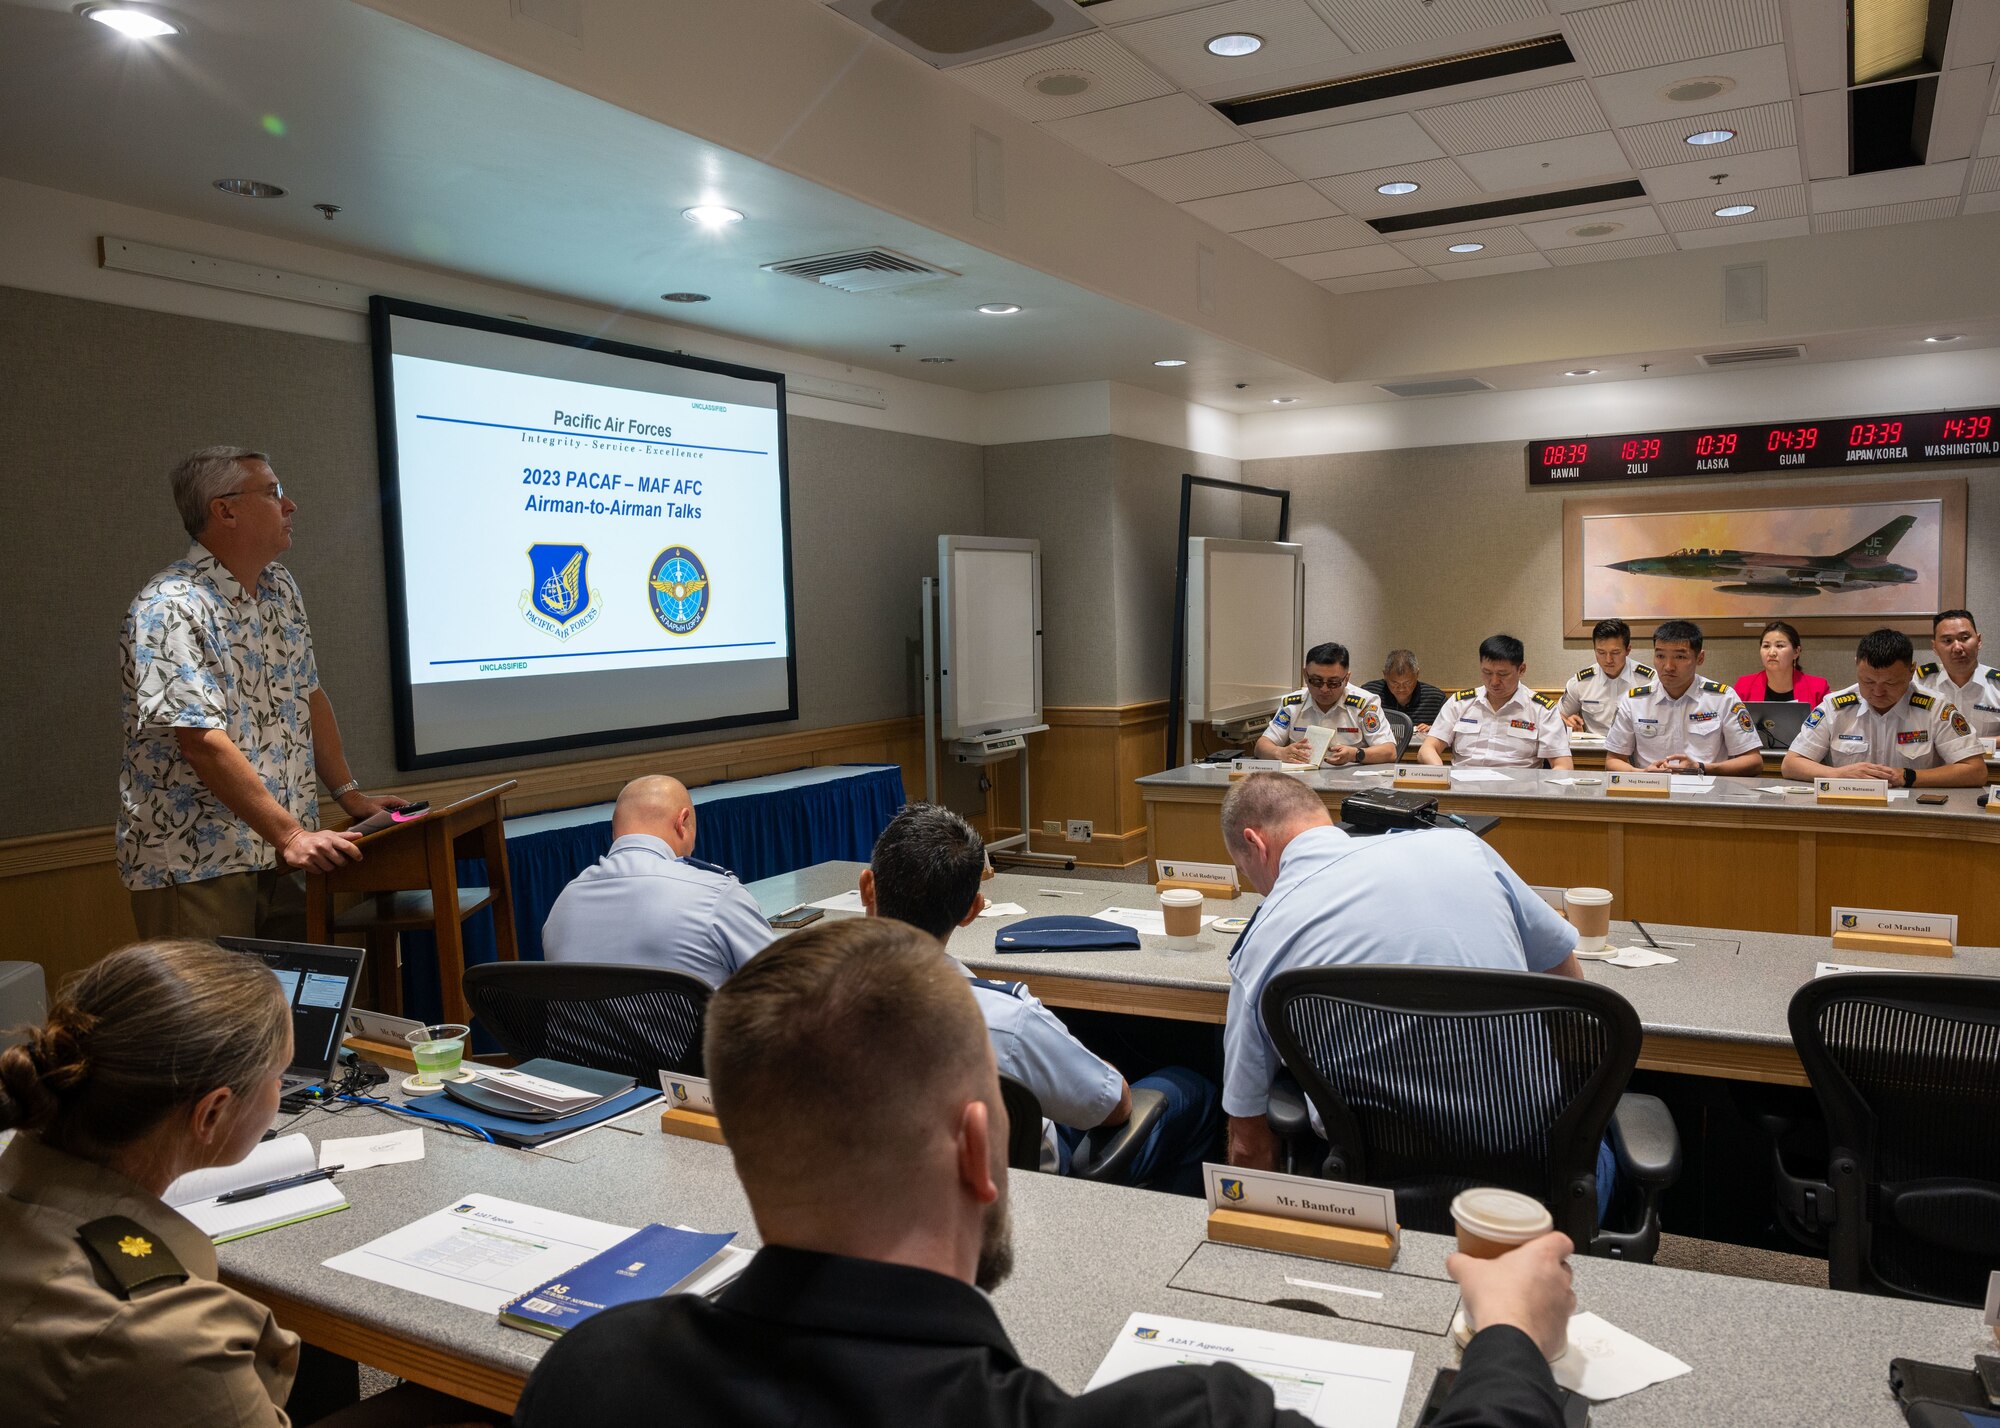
[750,856,2000,1046]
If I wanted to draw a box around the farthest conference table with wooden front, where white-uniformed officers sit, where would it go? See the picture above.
[1138,764,2000,946]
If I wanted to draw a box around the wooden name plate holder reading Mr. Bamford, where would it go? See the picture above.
[1202,1164,1402,1270]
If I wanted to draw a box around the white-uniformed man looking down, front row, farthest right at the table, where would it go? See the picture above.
[1784,630,1986,788]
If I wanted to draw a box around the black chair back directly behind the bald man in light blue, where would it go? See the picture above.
[464,962,710,1086]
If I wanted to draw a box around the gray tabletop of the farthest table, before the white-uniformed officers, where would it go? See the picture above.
[1138,764,2000,816]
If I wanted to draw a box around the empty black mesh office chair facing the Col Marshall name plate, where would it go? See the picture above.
[1788,972,2000,1306]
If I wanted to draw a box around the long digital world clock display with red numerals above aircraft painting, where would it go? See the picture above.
[1528,406,2000,486]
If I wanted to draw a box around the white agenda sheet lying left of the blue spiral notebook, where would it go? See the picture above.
[326,1194,636,1314]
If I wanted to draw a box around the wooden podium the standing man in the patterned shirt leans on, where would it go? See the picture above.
[306,778,520,1024]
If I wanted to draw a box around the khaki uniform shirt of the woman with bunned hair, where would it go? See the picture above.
[0,1134,298,1428]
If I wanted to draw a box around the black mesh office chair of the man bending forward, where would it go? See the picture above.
[1262,966,1680,1262]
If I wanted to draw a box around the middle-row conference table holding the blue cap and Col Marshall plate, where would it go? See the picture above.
[750,862,2000,1086]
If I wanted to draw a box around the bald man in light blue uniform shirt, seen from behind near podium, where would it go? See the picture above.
[542,774,776,986]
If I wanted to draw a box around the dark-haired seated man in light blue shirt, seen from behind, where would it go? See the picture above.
[860,796,1216,1194]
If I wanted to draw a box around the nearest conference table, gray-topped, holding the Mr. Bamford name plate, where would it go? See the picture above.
[218,1104,1992,1428]
